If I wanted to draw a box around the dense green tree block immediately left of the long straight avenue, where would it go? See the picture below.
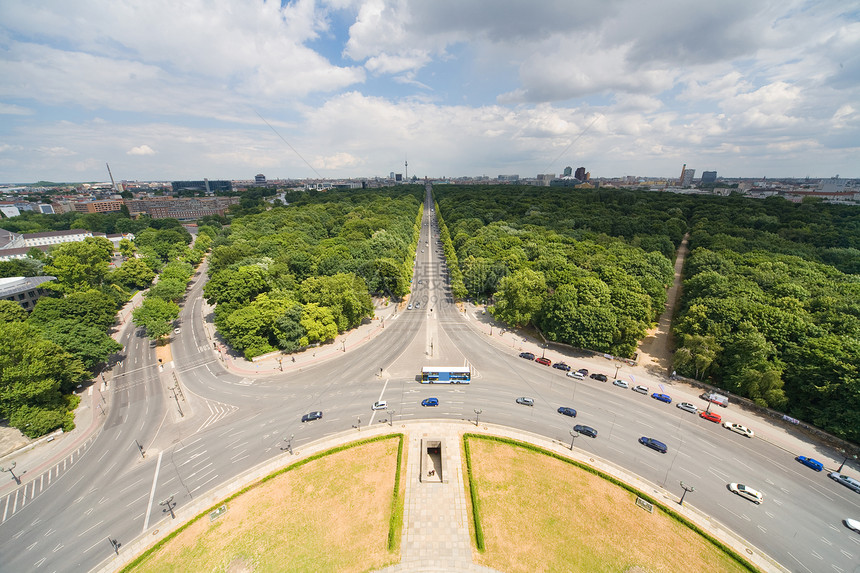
[204,186,423,358]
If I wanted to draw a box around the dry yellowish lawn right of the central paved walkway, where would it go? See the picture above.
[467,439,749,573]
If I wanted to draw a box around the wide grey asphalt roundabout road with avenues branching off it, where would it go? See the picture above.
[0,190,860,573]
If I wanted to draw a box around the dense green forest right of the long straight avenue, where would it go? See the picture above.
[434,186,860,442]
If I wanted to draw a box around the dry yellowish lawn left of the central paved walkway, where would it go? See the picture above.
[129,439,402,573]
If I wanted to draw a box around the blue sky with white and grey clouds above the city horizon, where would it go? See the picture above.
[0,0,860,182]
